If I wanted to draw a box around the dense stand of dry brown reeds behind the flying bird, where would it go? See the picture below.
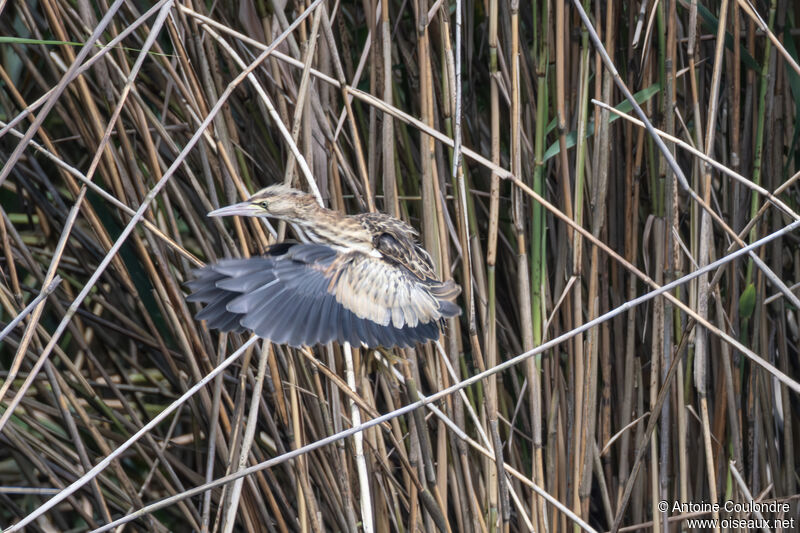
[0,0,800,532]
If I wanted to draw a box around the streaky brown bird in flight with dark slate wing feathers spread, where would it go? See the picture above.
[187,185,461,348]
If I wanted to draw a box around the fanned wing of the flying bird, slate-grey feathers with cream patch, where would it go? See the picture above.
[187,244,460,347]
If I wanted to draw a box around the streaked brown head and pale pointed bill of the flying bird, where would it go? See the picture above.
[208,185,319,222]
